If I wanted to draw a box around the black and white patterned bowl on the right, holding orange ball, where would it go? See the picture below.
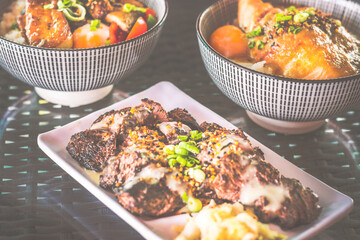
[196,0,360,133]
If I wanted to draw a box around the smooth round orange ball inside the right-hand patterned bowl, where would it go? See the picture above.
[209,25,249,58]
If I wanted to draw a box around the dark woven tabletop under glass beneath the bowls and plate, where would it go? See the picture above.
[0,0,360,240]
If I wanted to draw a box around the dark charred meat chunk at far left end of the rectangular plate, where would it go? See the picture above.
[66,129,116,172]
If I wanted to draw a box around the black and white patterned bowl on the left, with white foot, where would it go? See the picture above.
[0,0,168,105]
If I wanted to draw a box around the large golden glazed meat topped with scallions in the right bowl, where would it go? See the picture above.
[238,0,360,79]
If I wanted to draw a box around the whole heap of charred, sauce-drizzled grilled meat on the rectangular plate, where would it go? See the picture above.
[67,99,321,228]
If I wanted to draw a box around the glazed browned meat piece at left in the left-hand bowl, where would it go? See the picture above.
[25,0,73,48]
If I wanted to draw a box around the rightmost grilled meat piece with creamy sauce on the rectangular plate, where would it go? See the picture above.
[198,125,321,228]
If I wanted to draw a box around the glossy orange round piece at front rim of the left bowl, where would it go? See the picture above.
[73,23,109,48]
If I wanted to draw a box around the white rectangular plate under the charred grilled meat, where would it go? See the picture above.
[38,82,353,239]
